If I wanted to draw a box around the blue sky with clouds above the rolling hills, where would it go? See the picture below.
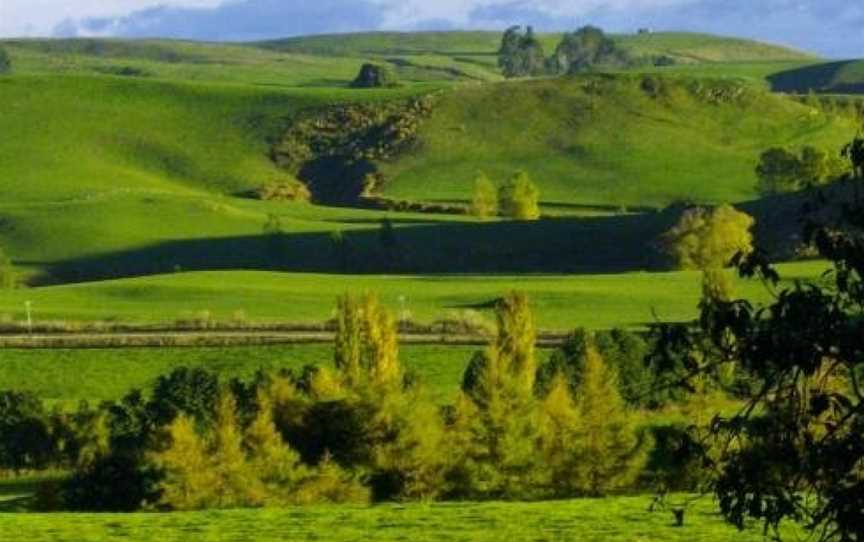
[0,0,864,58]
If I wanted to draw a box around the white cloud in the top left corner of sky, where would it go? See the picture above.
[0,0,226,37]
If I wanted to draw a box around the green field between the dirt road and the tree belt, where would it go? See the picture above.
[0,345,486,408]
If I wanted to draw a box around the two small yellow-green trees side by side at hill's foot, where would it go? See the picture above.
[470,171,540,220]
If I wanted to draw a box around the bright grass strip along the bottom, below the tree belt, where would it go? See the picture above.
[0,497,796,542]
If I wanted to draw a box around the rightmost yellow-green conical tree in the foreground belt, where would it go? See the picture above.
[573,347,646,495]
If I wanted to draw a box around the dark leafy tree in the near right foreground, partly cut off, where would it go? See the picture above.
[652,151,864,541]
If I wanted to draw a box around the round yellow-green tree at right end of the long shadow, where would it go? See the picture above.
[661,205,756,271]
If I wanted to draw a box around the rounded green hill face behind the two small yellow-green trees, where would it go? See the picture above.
[381,75,857,207]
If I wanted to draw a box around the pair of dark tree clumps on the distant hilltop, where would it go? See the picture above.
[498,26,640,77]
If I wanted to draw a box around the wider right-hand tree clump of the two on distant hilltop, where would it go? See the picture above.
[552,26,627,74]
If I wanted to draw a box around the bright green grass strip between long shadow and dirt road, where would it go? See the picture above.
[0,262,825,331]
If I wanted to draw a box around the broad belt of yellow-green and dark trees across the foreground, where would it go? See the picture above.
[0,294,650,510]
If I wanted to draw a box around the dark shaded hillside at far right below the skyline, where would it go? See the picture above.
[768,60,864,94]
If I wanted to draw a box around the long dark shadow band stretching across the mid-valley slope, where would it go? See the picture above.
[38,213,676,284]
